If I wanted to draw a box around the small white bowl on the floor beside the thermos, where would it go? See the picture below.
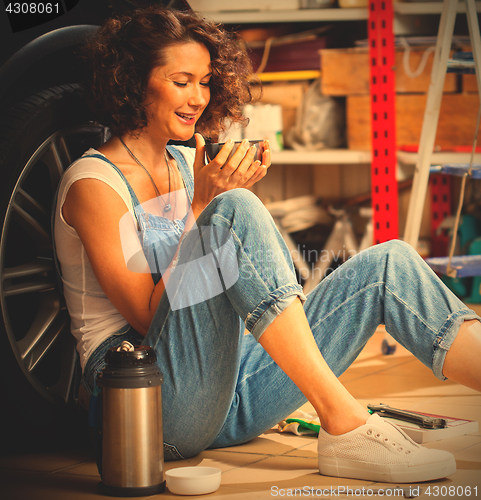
[165,467,220,495]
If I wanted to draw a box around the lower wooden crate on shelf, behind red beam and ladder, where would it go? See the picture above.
[346,93,481,150]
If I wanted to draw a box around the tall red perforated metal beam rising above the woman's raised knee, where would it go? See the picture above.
[368,0,399,244]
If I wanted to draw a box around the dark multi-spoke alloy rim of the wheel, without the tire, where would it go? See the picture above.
[0,123,108,403]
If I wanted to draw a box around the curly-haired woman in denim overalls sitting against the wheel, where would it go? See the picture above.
[55,8,481,482]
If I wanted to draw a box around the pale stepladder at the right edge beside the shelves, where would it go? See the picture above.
[404,0,481,277]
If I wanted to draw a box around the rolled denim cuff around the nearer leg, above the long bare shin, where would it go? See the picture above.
[245,283,306,342]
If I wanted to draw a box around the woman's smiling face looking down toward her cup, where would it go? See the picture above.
[145,42,211,141]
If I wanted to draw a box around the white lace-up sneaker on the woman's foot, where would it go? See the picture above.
[317,414,456,483]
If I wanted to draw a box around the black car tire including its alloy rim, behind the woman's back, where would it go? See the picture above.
[0,84,108,448]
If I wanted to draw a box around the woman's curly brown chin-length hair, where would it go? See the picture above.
[82,6,260,137]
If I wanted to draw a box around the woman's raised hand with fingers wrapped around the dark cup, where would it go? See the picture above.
[192,134,271,218]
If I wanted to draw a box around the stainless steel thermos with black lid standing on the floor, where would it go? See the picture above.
[97,343,165,497]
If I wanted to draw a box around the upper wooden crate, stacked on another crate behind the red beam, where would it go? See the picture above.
[319,47,457,96]
